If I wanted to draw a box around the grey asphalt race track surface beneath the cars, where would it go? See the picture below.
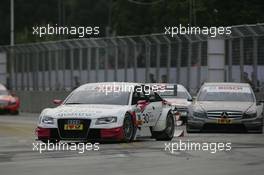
[0,114,264,175]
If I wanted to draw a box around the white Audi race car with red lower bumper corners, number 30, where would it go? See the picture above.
[36,82,175,142]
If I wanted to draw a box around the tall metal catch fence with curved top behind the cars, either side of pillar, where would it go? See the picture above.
[0,24,264,92]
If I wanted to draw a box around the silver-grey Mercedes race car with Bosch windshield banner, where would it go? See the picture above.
[186,83,263,133]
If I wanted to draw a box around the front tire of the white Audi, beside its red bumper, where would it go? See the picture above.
[122,114,136,142]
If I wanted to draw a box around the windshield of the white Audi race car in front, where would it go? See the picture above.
[65,90,129,105]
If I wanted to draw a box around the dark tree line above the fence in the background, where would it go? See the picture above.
[0,0,264,45]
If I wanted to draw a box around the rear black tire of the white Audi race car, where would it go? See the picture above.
[150,113,175,141]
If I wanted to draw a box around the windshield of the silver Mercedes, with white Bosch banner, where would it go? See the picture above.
[197,86,254,102]
